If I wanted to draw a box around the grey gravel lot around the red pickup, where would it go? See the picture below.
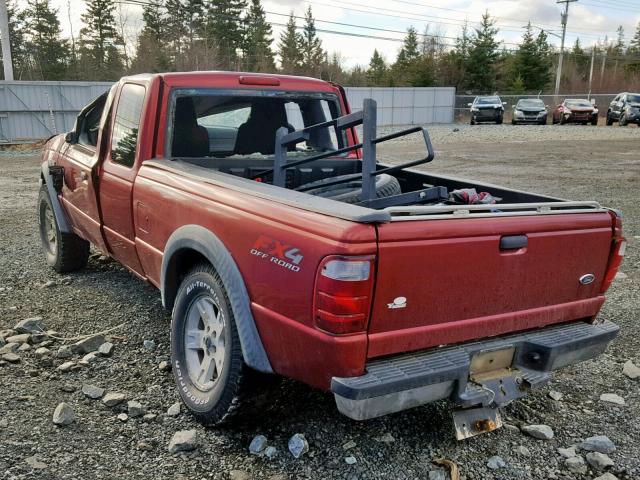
[0,125,640,480]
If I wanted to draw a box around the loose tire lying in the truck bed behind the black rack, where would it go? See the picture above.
[296,173,402,203]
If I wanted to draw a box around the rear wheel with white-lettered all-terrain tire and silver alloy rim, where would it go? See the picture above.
[171,264,248,425]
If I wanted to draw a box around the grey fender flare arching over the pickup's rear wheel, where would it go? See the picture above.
[160,225,273,373]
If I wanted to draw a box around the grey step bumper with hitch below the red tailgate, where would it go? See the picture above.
[331,321,619,420]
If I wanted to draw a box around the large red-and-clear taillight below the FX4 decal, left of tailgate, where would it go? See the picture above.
[313,256,375,335]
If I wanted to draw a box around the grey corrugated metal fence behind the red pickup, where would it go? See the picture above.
[0,81,456,143]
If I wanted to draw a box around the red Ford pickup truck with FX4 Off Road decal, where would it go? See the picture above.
[38,72,626,438]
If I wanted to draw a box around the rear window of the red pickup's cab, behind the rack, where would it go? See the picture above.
[168,89,345,158]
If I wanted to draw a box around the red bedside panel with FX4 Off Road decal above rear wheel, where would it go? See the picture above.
[133,169,376,388]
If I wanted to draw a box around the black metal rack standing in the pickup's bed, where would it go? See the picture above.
[253,98,448,209]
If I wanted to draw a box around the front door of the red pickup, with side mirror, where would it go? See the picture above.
[58,93,108,250]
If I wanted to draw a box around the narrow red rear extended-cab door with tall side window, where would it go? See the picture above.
[99,83,146,276]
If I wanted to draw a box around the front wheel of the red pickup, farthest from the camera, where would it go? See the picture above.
[38,185,90,273]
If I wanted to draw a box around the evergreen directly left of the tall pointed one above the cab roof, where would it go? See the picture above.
[205,0,247,70]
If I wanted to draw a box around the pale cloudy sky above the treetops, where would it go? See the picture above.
[40,0,640,67]
